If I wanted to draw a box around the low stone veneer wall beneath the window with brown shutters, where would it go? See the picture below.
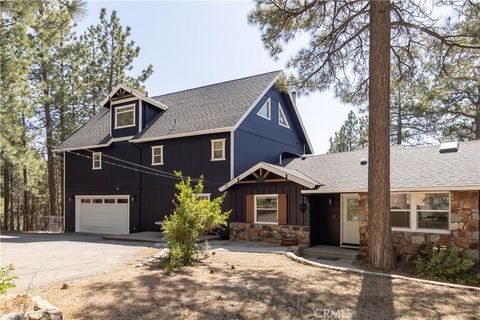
[230,222,310,245]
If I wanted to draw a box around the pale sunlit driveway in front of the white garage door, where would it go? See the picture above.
[0,233,153,292]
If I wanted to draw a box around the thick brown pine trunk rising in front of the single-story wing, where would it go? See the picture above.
[368,1,395,270]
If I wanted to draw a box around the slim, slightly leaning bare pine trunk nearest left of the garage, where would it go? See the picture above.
[42,66,57,215]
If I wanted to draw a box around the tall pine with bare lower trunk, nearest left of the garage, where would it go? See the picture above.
[30,2,82,215]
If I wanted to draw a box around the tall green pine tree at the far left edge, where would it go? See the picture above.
[0,1,35,229]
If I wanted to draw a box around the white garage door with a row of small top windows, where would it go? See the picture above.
[75,196,130,234]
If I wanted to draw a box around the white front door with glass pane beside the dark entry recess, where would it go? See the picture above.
[342,194,363,246]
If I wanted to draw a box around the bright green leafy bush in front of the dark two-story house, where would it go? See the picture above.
[163,172,230,270]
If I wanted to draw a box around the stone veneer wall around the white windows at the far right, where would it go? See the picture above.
[359,191,480,260]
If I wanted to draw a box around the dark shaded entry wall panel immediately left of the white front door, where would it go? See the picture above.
[310,194,340,246]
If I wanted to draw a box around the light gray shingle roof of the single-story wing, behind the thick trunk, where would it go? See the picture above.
[285,141,480,192]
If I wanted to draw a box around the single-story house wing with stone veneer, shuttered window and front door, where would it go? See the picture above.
[220,141,480,259]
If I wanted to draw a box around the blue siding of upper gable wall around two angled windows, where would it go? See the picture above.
[234,88,310,176]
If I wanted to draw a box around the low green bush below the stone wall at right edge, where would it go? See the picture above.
[415,242,480,284]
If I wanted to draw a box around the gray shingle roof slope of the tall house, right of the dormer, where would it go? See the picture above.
[134,71,281,139]
